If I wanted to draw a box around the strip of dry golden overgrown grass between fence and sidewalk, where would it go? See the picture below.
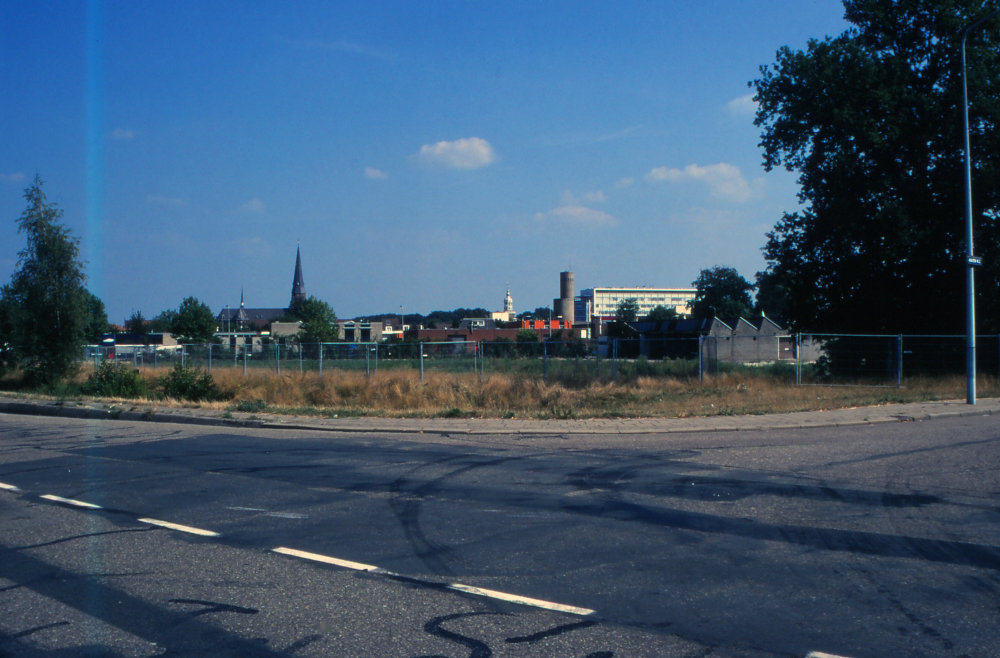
[3,358,1000,418]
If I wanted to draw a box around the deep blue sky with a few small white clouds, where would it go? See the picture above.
[0,0,846,322]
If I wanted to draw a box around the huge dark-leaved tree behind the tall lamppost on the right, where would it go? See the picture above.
[751,0,1000,333]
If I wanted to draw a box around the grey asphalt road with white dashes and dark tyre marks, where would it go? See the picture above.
[0,415,1000,658]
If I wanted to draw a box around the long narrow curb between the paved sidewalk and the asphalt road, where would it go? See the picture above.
[0,401,1000,436]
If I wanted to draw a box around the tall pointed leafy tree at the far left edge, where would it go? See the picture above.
[0,176,90,385]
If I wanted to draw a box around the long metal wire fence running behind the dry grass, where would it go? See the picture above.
[83,334,1000,387]
